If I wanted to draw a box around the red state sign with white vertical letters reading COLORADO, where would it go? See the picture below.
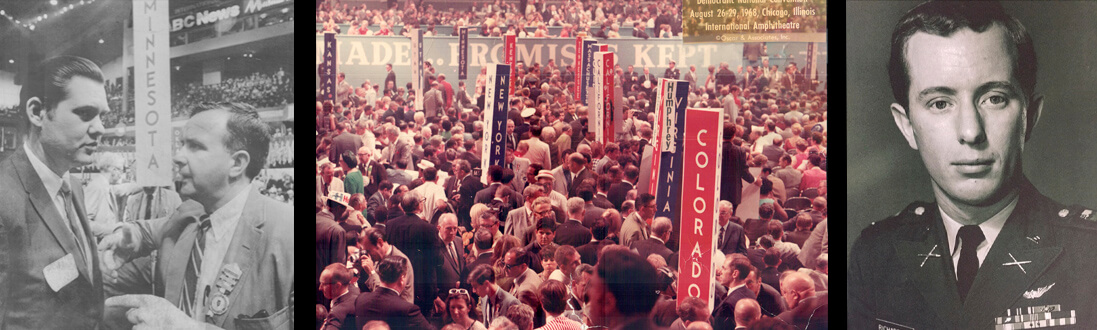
[678,109,724,310]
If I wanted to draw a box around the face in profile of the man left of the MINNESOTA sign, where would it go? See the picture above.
[41,76,110,166]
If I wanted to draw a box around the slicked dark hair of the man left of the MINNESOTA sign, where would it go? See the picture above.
[19,56,103,124]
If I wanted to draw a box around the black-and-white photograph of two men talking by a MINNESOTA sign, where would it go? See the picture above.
[0,0,295,329]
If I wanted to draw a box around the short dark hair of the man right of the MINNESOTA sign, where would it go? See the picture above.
[191,102,271,179]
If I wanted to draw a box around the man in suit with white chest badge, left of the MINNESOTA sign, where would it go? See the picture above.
[0,56,110,329]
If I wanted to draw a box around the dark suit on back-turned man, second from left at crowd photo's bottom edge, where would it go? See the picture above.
[354,287,434,330]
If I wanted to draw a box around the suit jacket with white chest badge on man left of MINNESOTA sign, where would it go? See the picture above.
[0,148,104,329]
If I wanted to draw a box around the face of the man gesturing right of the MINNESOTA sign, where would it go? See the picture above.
[174,110,239,200]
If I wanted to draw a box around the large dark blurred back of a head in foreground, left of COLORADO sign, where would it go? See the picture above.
[595,249,653,316]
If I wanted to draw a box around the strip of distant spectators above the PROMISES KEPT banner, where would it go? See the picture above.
[316,0,681,39]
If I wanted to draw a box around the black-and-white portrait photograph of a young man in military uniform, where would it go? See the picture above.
[845,1,1097,329]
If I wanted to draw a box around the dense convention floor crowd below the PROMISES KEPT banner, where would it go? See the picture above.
[316,32,828,330]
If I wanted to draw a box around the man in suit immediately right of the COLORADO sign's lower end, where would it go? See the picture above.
[712,257,758,329]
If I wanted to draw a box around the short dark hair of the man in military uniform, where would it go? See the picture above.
[887,1,1037,107]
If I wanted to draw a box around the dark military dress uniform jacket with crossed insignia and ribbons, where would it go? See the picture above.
[847,181,1097,329]
